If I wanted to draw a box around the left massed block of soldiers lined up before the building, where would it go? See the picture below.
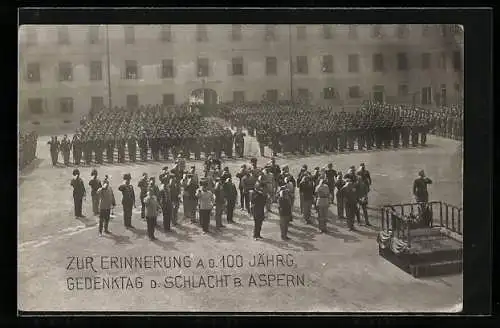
[49,106,244,165]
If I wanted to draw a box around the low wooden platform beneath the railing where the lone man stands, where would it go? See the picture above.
[379,228,463,278]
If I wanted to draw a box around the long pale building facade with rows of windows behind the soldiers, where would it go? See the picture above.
[19,25,463,118]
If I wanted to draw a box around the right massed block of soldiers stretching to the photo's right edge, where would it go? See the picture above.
[218,102,463,155]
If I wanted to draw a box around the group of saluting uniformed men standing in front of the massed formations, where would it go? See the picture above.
[71,158,371,240]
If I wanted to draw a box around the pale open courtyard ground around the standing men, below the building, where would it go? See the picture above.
[18,132,462,312]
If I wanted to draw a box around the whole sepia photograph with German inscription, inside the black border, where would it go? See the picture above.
[17,24,464,313]
